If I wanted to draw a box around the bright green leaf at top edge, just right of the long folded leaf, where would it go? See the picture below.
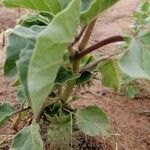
[81,0,119,25]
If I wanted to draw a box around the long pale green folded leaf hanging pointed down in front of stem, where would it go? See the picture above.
[28,0,80,117]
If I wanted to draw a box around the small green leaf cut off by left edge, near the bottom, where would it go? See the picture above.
[0,103,16,128]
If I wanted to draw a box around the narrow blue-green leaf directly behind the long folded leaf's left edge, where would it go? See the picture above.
[14,25,45,100]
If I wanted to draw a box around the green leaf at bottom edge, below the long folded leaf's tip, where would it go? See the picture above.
[10,123,44,150]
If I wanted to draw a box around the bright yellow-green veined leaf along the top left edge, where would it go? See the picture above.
[3,0,61,14]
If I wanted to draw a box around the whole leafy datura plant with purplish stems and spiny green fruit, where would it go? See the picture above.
[0,0,150,150]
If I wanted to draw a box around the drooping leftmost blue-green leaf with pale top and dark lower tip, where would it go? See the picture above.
[4,24,44,77]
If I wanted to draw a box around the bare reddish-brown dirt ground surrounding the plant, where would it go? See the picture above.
[0,0,150,150]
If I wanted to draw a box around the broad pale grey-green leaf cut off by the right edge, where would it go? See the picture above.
[119,33,150,80]
